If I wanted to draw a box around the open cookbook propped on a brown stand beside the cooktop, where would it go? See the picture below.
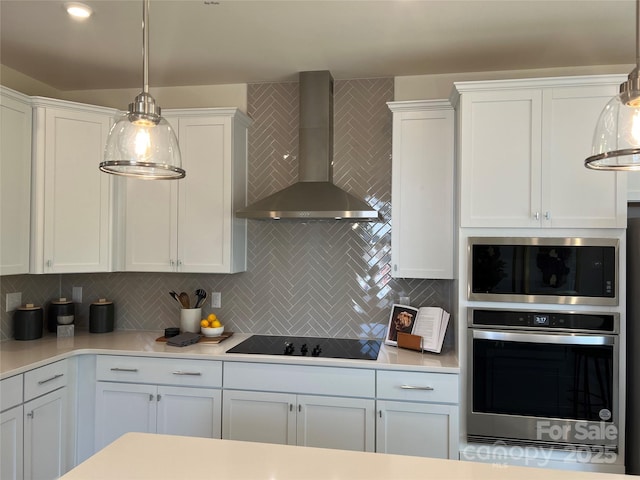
[384,305,450,353]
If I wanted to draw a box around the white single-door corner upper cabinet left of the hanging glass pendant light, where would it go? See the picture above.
[31,97,115,273]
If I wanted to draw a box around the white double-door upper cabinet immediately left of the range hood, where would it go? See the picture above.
[121,108,250,273]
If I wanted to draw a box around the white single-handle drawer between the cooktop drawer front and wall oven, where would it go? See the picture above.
[376,371,459,403]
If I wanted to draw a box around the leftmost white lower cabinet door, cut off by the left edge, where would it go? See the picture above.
[0,405,24,480]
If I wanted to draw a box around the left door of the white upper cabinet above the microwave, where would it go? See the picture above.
[460,89,542,227]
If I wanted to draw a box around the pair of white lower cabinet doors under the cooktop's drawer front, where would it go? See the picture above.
[222,390,375,452]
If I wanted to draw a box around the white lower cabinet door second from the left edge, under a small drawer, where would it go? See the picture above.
[24,387,67,480]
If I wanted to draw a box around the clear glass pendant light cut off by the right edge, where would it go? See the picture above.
[584,0,640,171]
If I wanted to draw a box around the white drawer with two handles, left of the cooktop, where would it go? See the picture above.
[96,355,222,387]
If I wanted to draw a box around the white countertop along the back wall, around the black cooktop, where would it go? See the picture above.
[0,330,460,378]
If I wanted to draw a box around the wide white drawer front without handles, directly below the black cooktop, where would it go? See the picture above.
[224,362,375,398]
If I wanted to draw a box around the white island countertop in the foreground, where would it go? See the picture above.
[61,433,635,480]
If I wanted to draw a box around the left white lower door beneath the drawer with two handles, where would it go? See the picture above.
[95,382,157,451]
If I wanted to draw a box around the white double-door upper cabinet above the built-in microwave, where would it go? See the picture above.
[454,75,626,228]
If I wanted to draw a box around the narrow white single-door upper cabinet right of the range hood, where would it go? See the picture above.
[388,100,455,279]
